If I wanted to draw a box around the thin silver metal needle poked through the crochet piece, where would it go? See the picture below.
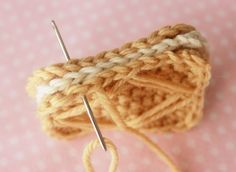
[52,20,107,151]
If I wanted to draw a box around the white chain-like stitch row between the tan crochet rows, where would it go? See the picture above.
[36,31,206,102]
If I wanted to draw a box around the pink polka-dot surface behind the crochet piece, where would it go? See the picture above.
[0,0,236,172]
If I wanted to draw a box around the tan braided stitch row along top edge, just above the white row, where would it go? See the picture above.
[26,24,195,97]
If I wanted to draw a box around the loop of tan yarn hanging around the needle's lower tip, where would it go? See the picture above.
[83,138,119,172]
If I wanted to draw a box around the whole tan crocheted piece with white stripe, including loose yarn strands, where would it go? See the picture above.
[27,24,210,172]
